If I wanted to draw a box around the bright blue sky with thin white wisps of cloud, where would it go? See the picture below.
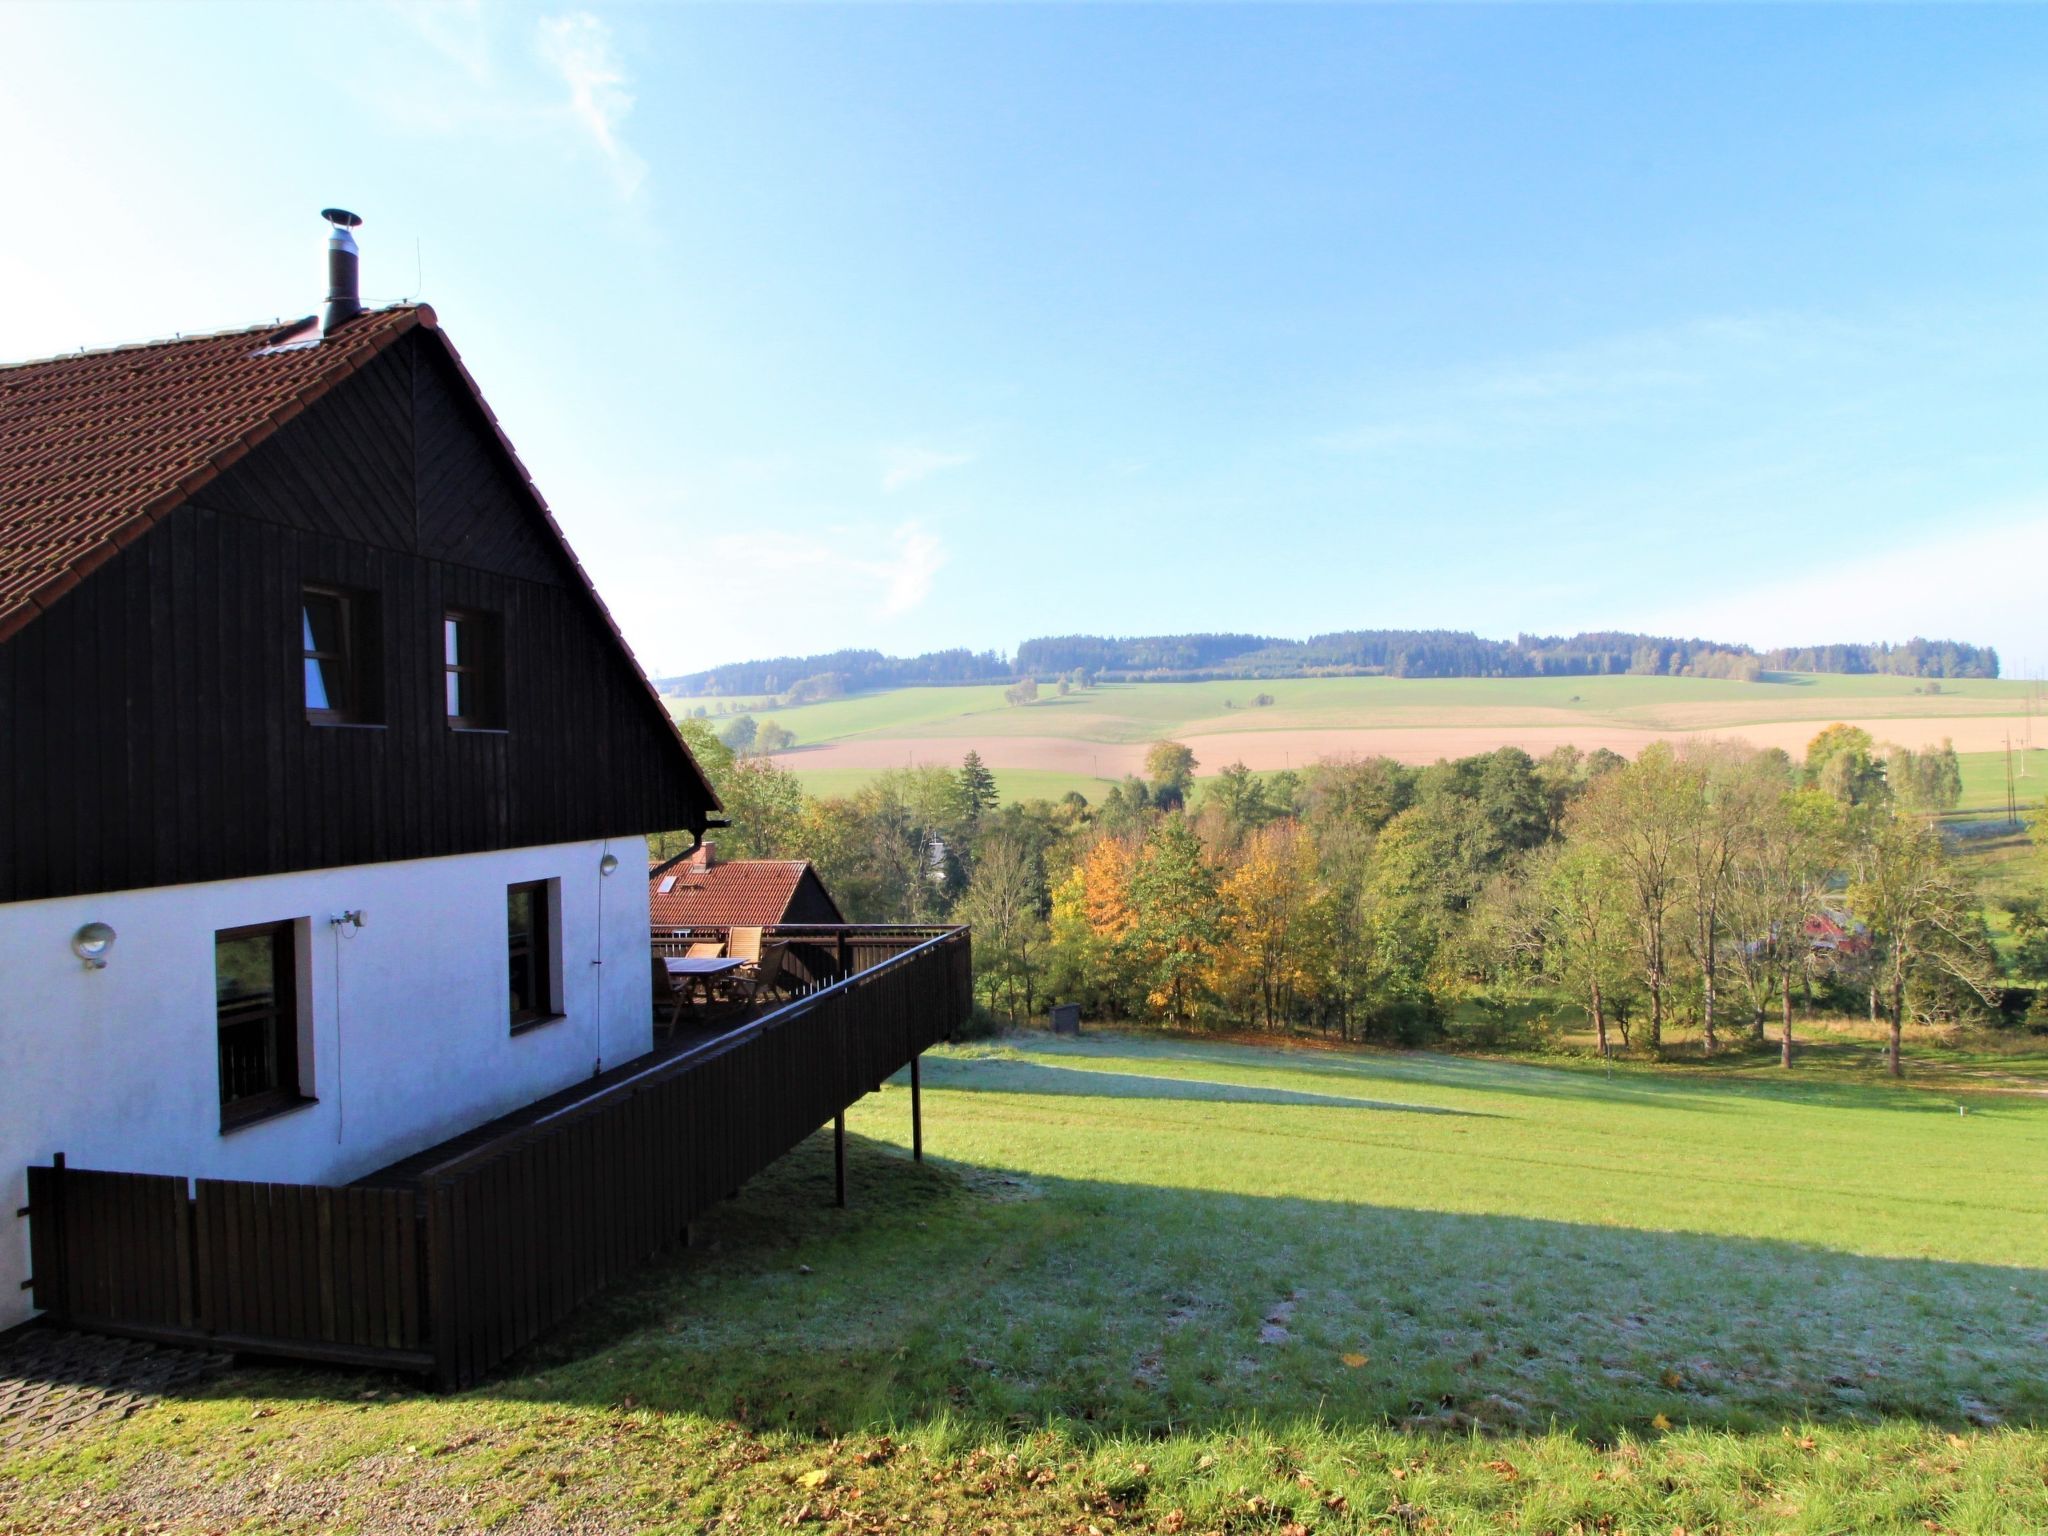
[0,2,2048,672]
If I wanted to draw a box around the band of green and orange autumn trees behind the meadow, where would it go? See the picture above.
[667,727,2015,1063]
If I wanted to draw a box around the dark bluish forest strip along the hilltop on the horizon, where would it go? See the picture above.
[662,629,1999,702]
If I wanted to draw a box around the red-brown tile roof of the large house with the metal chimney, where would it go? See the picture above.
[0,303,721,811]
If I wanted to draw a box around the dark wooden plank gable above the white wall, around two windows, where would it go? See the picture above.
[0,328,715,901]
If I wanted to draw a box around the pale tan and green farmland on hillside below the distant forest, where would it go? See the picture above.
[670,672,2048,799]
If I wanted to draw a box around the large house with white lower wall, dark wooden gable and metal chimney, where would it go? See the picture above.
[0,213,719,1327]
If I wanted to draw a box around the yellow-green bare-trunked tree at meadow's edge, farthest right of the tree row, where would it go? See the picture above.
[1849,817,1993,1077]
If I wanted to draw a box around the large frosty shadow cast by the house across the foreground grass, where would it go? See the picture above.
[464,1137,2048,1440]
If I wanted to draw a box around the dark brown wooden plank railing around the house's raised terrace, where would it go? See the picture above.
[29,928,973,1386]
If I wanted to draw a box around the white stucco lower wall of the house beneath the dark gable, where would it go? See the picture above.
[0,838,653,1327]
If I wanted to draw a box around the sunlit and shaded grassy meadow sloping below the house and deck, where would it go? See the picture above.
[12,1036,2048,1536]
